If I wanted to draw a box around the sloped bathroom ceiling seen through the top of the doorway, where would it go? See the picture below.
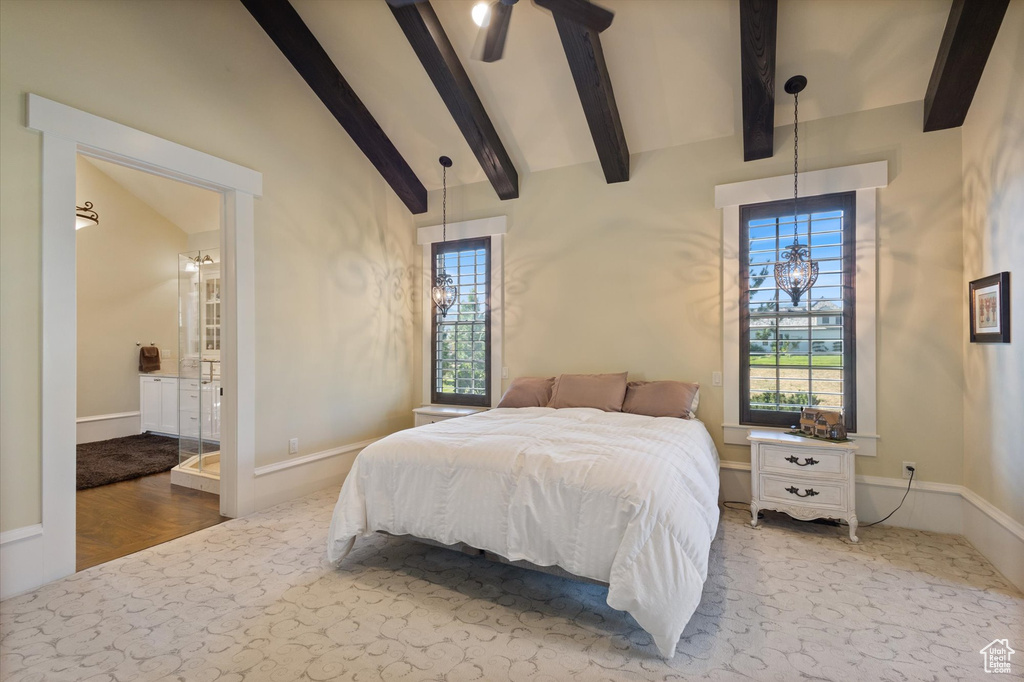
[85,157,220,235]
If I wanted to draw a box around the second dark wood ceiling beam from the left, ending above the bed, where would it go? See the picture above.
[388,2,519,199]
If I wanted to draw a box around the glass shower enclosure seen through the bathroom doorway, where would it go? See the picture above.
[171,249,221,493]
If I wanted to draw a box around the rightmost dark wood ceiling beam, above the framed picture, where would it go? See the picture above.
[925,0,1010,132]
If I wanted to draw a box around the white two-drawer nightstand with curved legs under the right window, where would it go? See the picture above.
[746,431,857,542]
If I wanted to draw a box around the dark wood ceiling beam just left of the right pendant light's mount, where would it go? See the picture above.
[739,0,778,161]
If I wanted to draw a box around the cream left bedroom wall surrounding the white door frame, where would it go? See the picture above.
[0,0,419,530]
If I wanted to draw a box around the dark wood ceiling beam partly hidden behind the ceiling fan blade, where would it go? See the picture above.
[538,9,630,183]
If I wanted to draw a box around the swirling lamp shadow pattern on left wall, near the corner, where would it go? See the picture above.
[265,169,416,391]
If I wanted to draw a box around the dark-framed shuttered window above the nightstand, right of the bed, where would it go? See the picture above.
[739,191,857,431]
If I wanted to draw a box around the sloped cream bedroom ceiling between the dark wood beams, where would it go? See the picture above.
[290,0,951,188]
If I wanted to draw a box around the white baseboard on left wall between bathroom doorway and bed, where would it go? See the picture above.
[255,438,379,510]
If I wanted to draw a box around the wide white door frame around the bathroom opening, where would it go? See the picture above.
[27,93,263,585]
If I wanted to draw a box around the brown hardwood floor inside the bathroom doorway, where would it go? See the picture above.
[76,471,227,570]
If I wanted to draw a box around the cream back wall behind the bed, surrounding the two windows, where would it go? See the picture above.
[416,100,964,483]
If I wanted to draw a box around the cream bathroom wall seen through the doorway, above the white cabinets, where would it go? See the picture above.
[75,157,187,417]
